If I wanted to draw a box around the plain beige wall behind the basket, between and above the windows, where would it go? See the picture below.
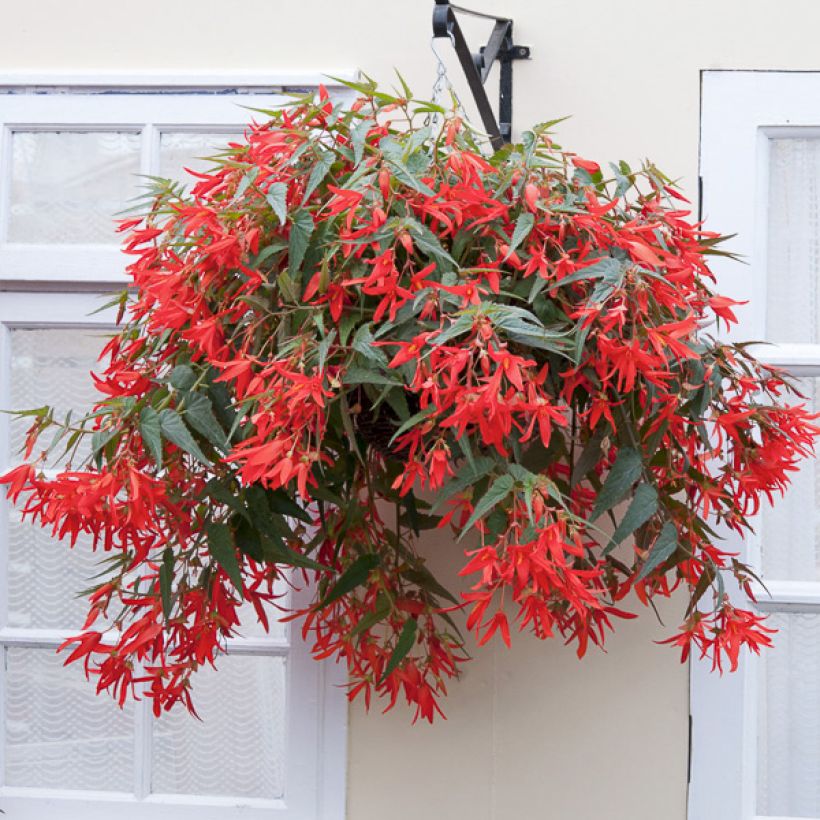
[0,0,820,820]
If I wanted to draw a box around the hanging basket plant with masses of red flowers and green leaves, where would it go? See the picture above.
[2,85,818,720]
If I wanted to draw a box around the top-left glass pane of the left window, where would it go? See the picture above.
[7,131,140,244]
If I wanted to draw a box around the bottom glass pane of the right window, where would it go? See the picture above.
[757,612,820,817]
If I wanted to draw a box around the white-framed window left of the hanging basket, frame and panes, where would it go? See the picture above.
[0,83,346,820]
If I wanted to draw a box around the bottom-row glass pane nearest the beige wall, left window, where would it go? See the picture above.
[151,655,285,798]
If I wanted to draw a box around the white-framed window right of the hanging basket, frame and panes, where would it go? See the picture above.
[690,71,820,820]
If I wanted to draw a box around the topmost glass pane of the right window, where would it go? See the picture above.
[766,139,820,343]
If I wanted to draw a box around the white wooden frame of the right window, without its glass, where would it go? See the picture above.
[688,71,820,820]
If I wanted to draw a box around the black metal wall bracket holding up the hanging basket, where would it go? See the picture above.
[433,0,530,150]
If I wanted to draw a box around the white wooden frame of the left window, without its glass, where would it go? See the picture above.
[0,72,355,820]
